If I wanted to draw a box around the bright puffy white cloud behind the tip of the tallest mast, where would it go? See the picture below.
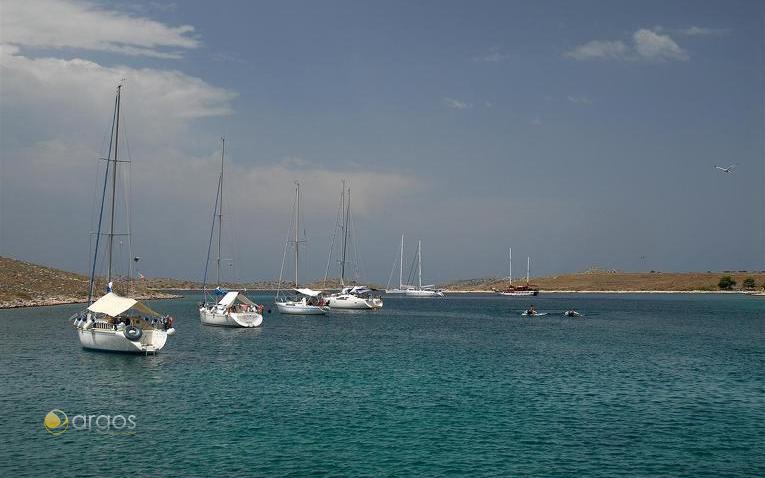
[0,45,236,141]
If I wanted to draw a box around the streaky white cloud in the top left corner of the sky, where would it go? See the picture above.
[0,0,199,58]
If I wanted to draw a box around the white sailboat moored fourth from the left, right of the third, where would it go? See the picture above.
[324,181,383,310]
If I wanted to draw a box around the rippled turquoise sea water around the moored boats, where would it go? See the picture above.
[0,295,765,476]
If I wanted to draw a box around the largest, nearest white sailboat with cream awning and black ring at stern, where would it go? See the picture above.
[72,85,175,354]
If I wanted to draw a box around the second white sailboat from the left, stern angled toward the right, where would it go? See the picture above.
[199,138,263,327]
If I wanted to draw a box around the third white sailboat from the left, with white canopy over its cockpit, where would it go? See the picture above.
[274,181,329,315]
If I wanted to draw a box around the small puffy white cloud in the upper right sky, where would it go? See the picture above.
[563,28,689,62]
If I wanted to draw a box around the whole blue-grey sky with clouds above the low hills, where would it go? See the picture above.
[0,0,765,284]
